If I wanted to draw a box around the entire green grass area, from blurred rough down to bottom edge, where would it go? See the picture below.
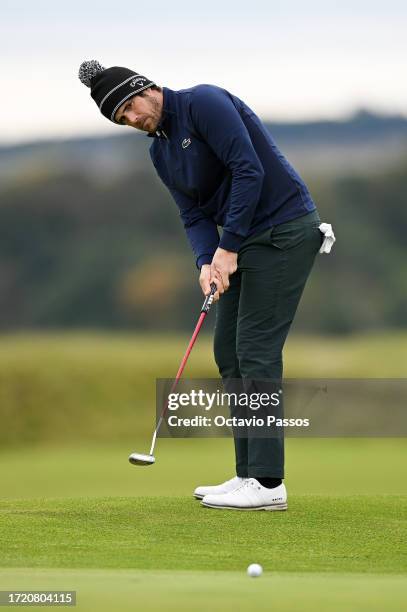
[0,332,407,612]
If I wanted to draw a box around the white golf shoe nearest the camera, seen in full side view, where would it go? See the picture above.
[201,478,287,510]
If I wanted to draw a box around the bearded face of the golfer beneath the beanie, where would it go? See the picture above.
[115,89,162,132]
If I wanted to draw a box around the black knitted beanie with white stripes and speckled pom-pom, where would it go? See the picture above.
[78,60,155,124]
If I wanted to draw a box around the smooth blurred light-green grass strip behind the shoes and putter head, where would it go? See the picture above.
[0,432,407,498]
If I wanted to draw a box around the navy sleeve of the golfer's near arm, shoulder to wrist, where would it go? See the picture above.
[190,85,264,252]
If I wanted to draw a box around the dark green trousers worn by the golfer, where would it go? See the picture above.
[214,211,323,478]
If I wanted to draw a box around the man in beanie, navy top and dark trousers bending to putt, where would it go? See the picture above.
[79,60,334,510]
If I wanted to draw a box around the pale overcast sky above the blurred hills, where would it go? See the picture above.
[0,0,407,143]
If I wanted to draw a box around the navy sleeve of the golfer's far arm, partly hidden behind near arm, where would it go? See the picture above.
[168,187,219,269]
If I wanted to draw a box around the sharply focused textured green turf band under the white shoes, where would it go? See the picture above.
[0,496,407,574]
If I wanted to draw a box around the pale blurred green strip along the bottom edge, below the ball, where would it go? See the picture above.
[0,560,407,612]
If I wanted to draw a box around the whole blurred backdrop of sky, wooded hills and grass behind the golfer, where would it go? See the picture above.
[0,0,407,497]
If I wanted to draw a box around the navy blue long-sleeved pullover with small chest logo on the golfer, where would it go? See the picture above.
[148,84,316,268]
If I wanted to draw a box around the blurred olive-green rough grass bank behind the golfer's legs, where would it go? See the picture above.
[0,330,407,446]
